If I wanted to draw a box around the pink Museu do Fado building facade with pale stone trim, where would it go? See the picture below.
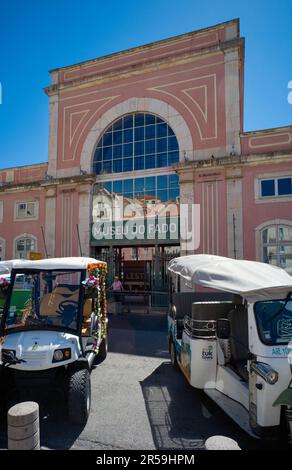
[0,20,292,272]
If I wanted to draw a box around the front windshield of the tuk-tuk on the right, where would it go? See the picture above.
[254,300,292,346]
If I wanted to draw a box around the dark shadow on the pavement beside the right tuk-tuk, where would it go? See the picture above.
[141,362,288,450]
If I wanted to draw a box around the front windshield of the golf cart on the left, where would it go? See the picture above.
[5,270,81,332]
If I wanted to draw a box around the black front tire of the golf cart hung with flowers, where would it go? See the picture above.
[68,369,91,425]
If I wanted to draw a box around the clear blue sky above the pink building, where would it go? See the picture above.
[0,0,292,168]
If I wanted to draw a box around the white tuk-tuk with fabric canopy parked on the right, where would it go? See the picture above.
[168,255,292,443]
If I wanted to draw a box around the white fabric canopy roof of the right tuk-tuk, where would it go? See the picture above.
[168,255,292,301]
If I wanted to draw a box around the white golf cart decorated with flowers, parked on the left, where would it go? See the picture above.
[0,257,107,424]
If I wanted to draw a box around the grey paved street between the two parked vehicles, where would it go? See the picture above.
[0,315,288,450]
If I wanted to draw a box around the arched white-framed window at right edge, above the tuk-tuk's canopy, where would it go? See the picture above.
[261,223,292,274]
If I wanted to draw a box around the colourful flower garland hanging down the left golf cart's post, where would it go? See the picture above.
[82,261,107,352]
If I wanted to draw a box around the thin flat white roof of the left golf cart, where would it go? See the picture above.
[12,256,106,271]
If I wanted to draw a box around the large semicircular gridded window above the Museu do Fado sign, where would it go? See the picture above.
[93,113,179,174]
